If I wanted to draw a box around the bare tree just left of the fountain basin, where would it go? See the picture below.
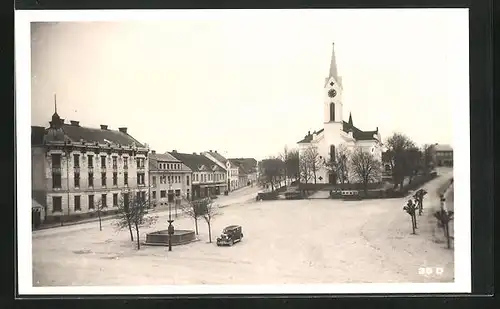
[116,189,158,250]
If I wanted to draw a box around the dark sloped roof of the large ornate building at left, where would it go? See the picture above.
[62,124,144,147]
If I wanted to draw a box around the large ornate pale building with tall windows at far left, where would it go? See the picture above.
[32,111,149,221]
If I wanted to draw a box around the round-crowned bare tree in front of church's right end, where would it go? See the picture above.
[350,147,381,195]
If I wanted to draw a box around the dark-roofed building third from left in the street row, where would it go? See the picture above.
[170,150,227,200]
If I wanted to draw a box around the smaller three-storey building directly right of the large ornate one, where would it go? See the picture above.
[149,150,193,207]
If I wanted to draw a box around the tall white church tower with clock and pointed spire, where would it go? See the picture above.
[323,42,343,145]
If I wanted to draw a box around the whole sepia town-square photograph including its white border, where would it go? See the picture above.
[16,9,471,294]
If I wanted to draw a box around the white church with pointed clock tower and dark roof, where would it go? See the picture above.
[297,46,382,184]
